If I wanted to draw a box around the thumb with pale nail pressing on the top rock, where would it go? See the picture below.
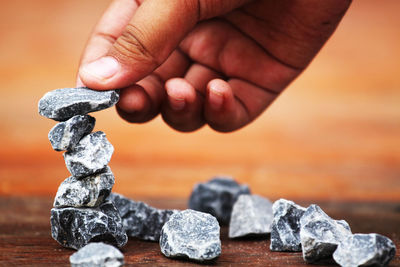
[79,0,248,90]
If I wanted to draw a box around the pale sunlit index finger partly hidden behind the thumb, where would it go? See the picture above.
[77,0,139,87]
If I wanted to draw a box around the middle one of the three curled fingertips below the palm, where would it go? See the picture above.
[162,78,205,132]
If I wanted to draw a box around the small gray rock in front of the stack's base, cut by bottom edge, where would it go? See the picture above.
[69,242,124,267]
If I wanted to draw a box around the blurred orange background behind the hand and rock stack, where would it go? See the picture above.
[0,0,400,202]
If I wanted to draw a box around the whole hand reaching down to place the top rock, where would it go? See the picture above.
[77,0,351,132]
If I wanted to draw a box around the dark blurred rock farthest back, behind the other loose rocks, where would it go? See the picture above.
[189,177,250,224]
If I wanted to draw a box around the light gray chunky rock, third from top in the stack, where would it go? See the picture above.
[64,131,114,178]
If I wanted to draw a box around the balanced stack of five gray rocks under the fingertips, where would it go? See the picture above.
[39,87,128,249]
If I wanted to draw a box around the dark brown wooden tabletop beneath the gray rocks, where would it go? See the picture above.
[0,197,400,266]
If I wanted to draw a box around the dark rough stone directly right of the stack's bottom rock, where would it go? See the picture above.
[108,193,178,242]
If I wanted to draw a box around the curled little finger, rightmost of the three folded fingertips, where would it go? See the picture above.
[204,79,276,132]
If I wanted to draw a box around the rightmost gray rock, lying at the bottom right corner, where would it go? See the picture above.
[333,234,396,267]
